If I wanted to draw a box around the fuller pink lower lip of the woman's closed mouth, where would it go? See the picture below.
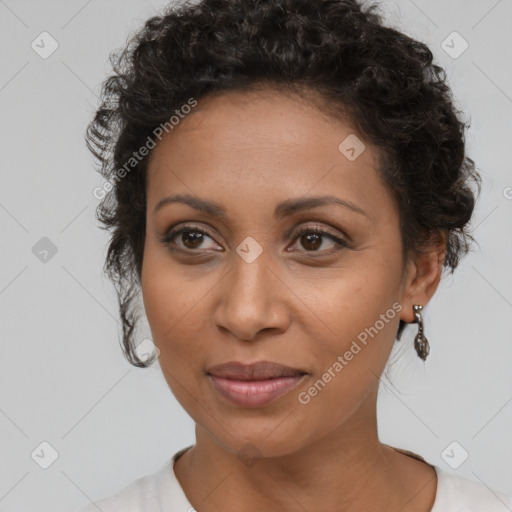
[209,375,305,408]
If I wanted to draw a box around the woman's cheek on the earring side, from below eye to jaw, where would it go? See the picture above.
[290,247,402,402]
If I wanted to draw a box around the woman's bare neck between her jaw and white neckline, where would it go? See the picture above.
[175,388,435,512]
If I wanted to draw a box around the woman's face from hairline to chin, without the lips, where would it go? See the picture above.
[142,87,414,456]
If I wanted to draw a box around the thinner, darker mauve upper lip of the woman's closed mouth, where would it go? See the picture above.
[206,361,307,380]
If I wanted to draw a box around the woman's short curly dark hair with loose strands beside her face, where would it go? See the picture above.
[86,0,481,367]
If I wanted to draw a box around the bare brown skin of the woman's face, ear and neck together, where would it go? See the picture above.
[142,89,445,512]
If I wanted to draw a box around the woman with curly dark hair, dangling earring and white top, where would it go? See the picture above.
[79,0,512,512]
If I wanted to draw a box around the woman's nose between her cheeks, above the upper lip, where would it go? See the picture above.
[213,254,290,341]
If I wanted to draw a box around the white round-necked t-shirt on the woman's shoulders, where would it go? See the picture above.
[77,445,512,512]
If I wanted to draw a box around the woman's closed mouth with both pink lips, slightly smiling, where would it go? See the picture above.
[206,361,308,408]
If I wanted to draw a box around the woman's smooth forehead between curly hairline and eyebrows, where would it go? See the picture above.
[148,90,389,222]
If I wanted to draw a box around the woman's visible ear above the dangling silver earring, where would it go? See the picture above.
[400,233,446,323]
